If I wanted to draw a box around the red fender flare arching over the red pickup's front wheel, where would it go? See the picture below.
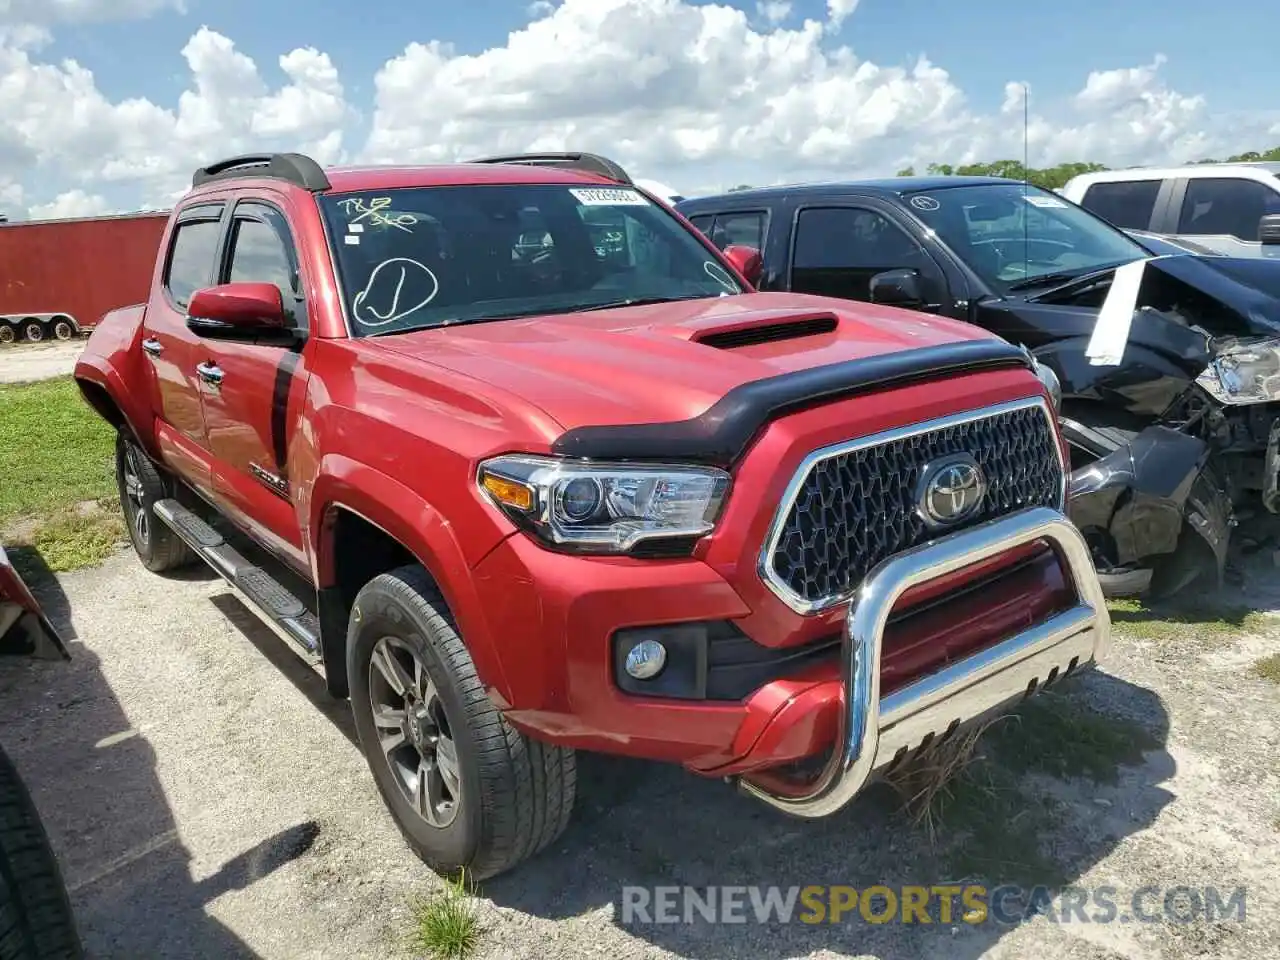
[307,453,511,703]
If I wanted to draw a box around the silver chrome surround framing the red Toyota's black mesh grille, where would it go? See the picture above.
[756,397,1068,616]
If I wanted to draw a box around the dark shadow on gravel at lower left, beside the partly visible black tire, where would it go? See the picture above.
[0,554,319,960]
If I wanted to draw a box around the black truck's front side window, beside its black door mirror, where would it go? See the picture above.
[791,207,925,301]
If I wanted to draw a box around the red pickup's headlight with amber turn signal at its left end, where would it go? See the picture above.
[479,456,730,553]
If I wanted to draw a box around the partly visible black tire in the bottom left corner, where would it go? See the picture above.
[0,750,84,960]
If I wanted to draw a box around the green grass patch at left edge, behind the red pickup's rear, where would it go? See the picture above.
[0,376,124,575]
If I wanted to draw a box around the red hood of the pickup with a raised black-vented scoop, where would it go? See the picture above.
[362,293,995,429]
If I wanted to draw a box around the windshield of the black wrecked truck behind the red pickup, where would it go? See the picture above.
[905,182,1147,293]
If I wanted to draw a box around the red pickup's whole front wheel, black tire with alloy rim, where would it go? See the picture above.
[347,566,577,879]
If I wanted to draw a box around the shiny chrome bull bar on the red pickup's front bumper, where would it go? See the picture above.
[739,507,1111,818]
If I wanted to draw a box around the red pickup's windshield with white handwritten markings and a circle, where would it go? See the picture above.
[320,184,744,337]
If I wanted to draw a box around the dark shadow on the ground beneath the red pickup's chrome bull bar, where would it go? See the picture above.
[480,672,1174,960]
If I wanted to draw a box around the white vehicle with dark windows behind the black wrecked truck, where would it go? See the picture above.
[1060,163,1280,260]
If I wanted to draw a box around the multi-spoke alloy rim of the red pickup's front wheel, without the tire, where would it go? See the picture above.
[369,636,462,829]
